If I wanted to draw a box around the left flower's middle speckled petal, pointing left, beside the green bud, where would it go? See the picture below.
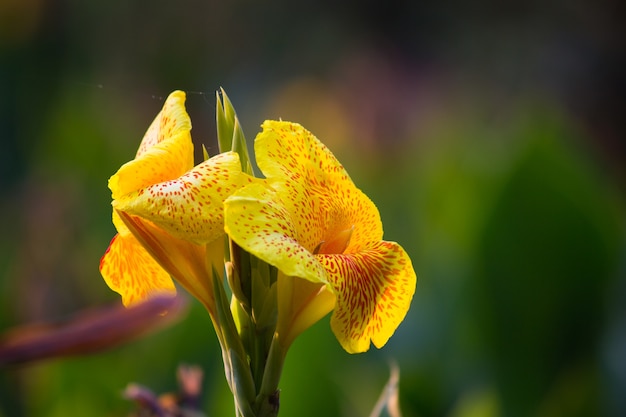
[113,152,253,244]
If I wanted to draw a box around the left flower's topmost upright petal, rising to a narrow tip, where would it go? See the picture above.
[109,91,193,200]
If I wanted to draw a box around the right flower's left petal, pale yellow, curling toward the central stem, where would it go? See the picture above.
[224,183,326,283]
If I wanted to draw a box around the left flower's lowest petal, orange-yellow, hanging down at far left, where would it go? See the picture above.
[100,234,176,307]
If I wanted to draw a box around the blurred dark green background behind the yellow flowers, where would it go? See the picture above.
[0,0,626,417]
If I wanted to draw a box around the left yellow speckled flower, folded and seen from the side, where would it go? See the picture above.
[100,91,251,313]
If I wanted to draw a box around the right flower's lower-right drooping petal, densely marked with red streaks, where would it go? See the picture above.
[317,241,417,353]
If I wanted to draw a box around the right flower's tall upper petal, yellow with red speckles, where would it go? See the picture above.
[254,121,383,252]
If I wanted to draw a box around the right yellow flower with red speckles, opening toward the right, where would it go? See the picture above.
[225,121,417,353]
